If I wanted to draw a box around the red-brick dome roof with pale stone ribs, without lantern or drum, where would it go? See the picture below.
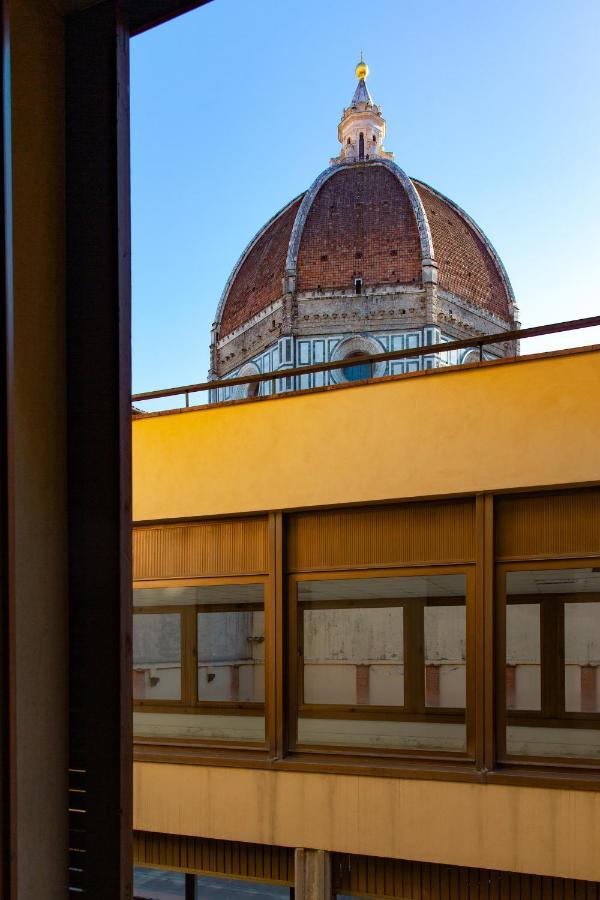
[215,159,514,338]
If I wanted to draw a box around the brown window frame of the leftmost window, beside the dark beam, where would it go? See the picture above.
[133,575,275,753]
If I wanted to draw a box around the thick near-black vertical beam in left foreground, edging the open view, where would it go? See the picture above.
[65,0,132,900]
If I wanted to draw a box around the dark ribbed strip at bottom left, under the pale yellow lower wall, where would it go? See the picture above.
[133,831,294,885]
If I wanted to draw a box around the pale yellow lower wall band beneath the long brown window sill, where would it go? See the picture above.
[134,763,600,881]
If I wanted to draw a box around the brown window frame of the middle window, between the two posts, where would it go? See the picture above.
[286,564,476,764]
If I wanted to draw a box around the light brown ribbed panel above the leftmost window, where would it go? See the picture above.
[133,517,268,579]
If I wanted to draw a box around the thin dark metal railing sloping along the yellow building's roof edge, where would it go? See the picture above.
[131,316,600,412]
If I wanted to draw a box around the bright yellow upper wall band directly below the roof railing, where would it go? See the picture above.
[133,350,600,521]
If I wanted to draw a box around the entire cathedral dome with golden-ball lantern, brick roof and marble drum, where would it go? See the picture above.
[209,60,519,400]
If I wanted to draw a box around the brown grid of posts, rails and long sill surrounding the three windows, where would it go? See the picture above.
[134,488,600,790]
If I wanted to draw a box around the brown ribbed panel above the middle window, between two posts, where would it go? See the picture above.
[288,500,475,571]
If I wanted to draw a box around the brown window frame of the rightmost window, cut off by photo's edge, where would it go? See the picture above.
[494,557,600,777]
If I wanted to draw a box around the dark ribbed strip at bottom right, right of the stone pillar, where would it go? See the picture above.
[332,853,600,900]
